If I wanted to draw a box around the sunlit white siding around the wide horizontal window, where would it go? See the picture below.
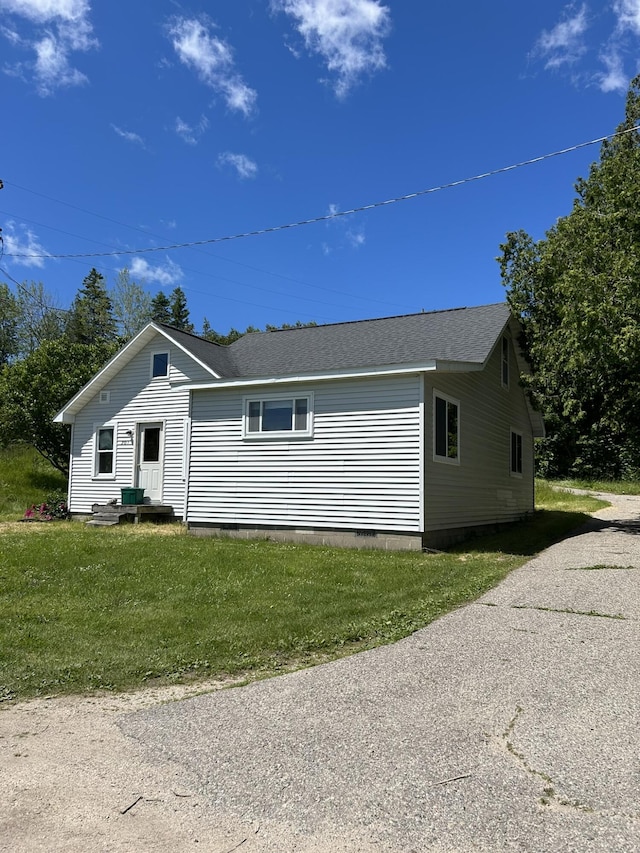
[187,376,422,532]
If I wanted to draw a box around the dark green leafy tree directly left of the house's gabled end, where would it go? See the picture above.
[0,339,116,475]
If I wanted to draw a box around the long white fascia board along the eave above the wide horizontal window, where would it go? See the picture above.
[181,360,482,391]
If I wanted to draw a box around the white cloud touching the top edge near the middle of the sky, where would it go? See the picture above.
[271,0,391,98]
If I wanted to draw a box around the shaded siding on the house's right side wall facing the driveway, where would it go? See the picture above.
[424,339,534,531]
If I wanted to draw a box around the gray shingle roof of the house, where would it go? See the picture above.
[166,303,510,378]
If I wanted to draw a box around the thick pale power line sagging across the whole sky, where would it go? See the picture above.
[7,126,638,260]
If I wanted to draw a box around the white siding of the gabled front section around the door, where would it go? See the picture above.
[69,336,211,517]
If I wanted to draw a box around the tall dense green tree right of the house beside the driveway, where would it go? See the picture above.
[499,77,640,479]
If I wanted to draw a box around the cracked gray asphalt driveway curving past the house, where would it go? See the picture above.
[120,497,640,853]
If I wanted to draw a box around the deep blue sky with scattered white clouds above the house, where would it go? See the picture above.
[0,0,640,332]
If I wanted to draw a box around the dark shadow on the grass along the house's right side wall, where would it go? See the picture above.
[451,509,592,557]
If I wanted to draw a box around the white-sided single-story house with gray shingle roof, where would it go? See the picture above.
[55,303,543,548]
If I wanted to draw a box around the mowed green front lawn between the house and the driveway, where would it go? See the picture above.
[0,480,604,700]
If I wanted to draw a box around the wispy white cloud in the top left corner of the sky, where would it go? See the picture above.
[0,0,98,96]
